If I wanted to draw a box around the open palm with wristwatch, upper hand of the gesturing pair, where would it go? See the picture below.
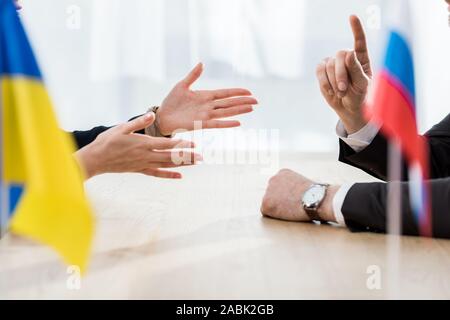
[156,63,258,135]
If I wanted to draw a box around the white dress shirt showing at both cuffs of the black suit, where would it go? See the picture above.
[333,121,380,227]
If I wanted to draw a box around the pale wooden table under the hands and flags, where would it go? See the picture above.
[0,154,450,299]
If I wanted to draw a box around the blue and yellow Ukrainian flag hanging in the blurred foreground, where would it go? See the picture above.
[0,0,94,271]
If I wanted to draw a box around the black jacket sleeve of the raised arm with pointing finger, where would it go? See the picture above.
[339,115,450,180]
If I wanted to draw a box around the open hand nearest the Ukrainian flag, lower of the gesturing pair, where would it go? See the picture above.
[76,113,201,179]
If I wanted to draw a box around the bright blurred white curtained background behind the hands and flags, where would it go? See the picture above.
[21,0,450,152]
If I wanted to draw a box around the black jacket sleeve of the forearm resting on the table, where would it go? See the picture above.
[342,178,450,238]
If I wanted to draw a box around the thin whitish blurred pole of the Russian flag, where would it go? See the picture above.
[387,141,403,299]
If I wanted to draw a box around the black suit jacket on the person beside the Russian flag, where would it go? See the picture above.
[339,114,450,238]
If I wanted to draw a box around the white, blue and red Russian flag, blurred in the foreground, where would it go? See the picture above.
[370,1,432,237]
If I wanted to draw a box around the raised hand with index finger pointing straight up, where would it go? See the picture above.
[317,16,373,134]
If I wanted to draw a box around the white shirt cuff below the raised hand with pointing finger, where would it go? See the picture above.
[336,120,380,152]
